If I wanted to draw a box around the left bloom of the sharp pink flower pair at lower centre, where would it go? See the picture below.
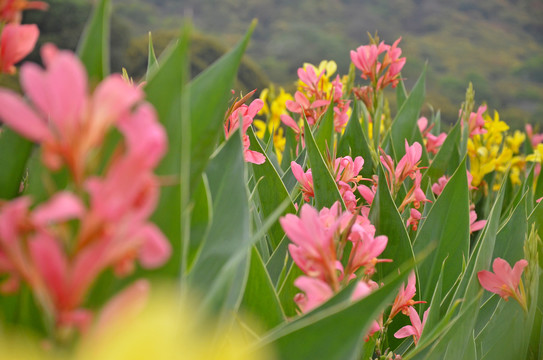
[279,204,340,290]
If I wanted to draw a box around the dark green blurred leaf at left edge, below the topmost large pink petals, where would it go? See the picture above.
[0,126,33,200]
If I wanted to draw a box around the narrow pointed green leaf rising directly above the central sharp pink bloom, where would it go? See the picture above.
[304,119,345,209]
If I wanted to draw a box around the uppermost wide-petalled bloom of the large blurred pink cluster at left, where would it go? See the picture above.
[0,44,143,183]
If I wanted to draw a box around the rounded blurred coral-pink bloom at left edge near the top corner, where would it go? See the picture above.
[0,24,40,74]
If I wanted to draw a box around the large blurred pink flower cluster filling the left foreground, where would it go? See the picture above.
[0,45,171,338]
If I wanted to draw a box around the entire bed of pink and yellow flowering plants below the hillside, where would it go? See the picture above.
[0,0,543,360]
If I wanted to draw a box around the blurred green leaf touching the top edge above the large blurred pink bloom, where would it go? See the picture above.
[77,0,111,84]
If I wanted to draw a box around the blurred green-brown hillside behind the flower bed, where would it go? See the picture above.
[17,0,543,127]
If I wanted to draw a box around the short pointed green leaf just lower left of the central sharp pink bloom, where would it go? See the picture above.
[241,247,285,330]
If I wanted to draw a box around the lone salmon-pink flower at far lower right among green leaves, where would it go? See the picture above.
[477,258,528,310]
